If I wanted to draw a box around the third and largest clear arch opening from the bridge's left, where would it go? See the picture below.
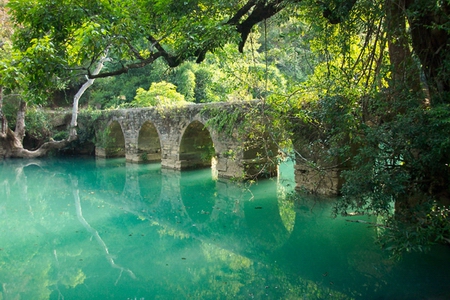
[179,121,215,169]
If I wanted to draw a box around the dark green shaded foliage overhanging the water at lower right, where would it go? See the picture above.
[333,88,450,258]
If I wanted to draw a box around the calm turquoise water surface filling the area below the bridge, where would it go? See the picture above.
[0,158,450,299]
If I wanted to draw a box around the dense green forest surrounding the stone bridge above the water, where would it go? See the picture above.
[0,0,450,255]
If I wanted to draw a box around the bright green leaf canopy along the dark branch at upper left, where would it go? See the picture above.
[2,0,243,100]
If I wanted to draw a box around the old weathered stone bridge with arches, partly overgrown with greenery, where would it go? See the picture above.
[95,101,340,195]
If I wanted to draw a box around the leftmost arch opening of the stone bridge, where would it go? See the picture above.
[97,121,125,157]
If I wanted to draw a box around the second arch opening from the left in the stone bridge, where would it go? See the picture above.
[137,121,161,162]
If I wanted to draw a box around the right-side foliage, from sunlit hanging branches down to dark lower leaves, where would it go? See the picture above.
[269,1,450,256]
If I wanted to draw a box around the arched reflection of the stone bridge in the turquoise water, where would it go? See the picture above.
[97,160,294,254]
